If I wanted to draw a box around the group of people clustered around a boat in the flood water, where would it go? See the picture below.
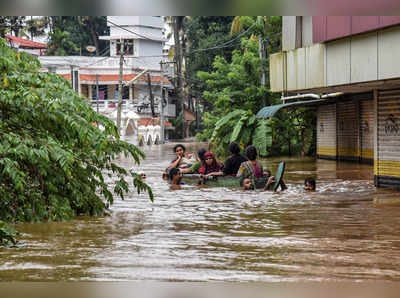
[164,142,315,190]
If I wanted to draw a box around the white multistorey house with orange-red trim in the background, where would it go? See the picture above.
[39,16,175,118]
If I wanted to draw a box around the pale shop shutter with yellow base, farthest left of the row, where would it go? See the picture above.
[317,104,337,159]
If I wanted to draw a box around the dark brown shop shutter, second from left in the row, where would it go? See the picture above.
[337,101,360,161]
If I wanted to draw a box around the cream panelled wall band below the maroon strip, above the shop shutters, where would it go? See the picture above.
[270,26,400,92]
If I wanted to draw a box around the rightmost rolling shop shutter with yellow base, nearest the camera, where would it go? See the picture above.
[374,89,400,188]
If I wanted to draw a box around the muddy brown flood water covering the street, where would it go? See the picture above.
[0,144,400,281]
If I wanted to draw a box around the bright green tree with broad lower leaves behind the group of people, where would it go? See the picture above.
[198,37,276,156]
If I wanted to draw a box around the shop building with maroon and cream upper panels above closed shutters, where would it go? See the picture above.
[270,16,400,188]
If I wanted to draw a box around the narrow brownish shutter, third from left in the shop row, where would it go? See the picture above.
[360,98,375,164]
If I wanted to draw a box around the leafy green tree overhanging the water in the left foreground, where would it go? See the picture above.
[0,39,153,246]
